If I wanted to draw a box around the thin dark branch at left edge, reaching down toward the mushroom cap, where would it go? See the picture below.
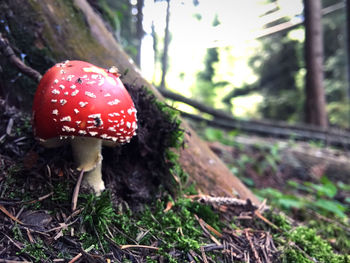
[0,33,42,82]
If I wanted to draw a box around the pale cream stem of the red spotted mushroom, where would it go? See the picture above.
[71,137,105,194]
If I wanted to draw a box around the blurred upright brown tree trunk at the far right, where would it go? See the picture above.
[304,0,328,127]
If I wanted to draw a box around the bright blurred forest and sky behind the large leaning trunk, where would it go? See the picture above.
[90,0,349,127]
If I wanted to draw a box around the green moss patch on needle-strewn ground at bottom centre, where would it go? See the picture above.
[109,198,221,262]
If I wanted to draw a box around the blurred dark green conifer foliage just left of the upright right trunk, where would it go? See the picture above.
[250,34,303,121]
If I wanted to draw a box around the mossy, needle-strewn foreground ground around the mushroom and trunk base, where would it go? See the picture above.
[0,95,350,263]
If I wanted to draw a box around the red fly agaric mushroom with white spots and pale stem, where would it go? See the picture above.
[33,61,137,194]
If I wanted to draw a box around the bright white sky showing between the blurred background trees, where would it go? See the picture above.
[141,0,303,109]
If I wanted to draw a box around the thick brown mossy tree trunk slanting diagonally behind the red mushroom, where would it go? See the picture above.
[0,0,259,203]
